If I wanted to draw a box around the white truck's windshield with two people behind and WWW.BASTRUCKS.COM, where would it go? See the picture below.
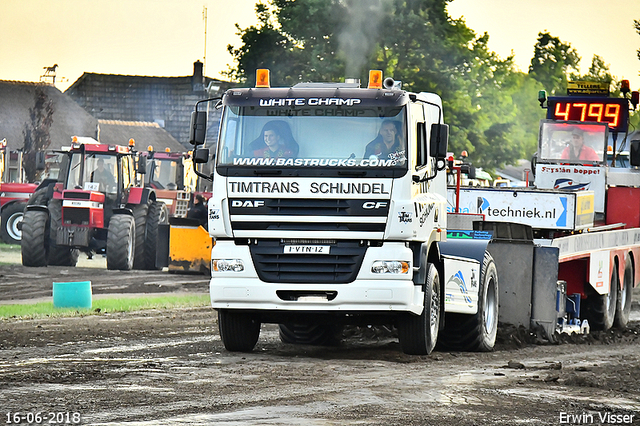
[217,105,407,174]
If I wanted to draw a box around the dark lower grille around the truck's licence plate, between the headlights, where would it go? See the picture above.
[249,240,367,284]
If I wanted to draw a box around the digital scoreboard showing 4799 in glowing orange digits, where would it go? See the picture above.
[547,96,629,133]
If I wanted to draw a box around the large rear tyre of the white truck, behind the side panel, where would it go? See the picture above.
[440,252,499,352]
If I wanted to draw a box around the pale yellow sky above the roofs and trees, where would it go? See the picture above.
[0,0,640,91]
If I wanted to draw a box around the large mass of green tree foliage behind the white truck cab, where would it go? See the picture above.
[228,0,603,170]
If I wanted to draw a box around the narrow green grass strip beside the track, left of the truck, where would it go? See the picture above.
[0,294,211,319]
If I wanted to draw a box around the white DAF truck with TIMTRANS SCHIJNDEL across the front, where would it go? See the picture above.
[191,70,499,354]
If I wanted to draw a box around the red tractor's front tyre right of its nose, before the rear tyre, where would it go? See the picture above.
[107,214,136,271]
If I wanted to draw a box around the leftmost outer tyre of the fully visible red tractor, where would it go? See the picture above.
[20,210,49,267]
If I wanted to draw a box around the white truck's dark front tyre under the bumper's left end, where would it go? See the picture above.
[218,309,260,352]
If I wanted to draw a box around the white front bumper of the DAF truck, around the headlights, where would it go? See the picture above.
[209,241,424,314]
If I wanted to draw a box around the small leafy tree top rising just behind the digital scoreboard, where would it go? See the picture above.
[529,32,580,94]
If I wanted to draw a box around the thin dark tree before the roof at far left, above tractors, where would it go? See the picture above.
[22,87,54,182]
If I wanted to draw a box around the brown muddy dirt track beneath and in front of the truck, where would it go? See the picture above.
[0,266,640,426]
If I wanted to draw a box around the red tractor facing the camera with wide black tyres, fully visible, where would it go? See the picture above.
[21,141,163,270]
